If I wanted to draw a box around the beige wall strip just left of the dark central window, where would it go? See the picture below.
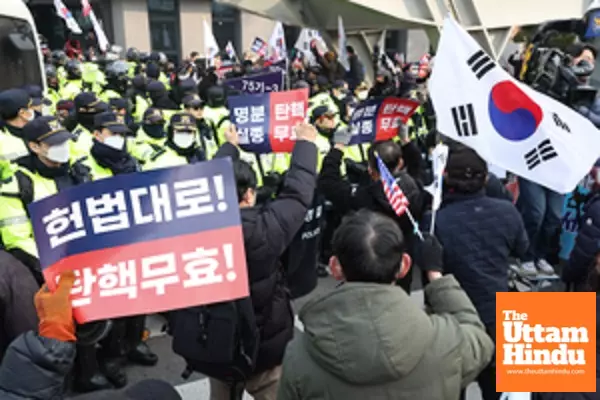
[112,0,151,51]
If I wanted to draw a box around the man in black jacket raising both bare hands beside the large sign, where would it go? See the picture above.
[210,124,317,400]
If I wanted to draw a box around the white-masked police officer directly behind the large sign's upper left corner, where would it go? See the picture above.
[0,117,90,284]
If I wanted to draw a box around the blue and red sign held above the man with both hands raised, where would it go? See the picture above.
[228,89,308,154]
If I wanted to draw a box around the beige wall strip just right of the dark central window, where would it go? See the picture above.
[179,0,212,58]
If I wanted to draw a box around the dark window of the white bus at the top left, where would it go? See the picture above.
[0,17,43,91]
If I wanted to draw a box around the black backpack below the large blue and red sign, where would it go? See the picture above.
[171,297,260,384]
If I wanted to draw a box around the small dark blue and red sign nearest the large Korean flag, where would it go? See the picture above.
[350,97,419,145]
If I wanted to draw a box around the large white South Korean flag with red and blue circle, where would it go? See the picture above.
[429,17,600,193]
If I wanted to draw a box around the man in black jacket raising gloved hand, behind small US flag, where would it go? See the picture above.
[319,130,422,292]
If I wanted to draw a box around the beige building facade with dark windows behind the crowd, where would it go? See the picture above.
[25,0,282,59]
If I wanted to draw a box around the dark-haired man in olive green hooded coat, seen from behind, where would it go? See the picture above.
[278,211,494,400]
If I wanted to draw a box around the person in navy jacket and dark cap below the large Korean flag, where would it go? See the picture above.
[435,144,529,400]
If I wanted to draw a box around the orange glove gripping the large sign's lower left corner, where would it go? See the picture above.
[34,271,76,342]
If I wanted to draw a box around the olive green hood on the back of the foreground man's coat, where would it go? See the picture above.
[300,283,433,385]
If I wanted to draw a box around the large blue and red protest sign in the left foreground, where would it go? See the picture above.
[29,159,248,323]
